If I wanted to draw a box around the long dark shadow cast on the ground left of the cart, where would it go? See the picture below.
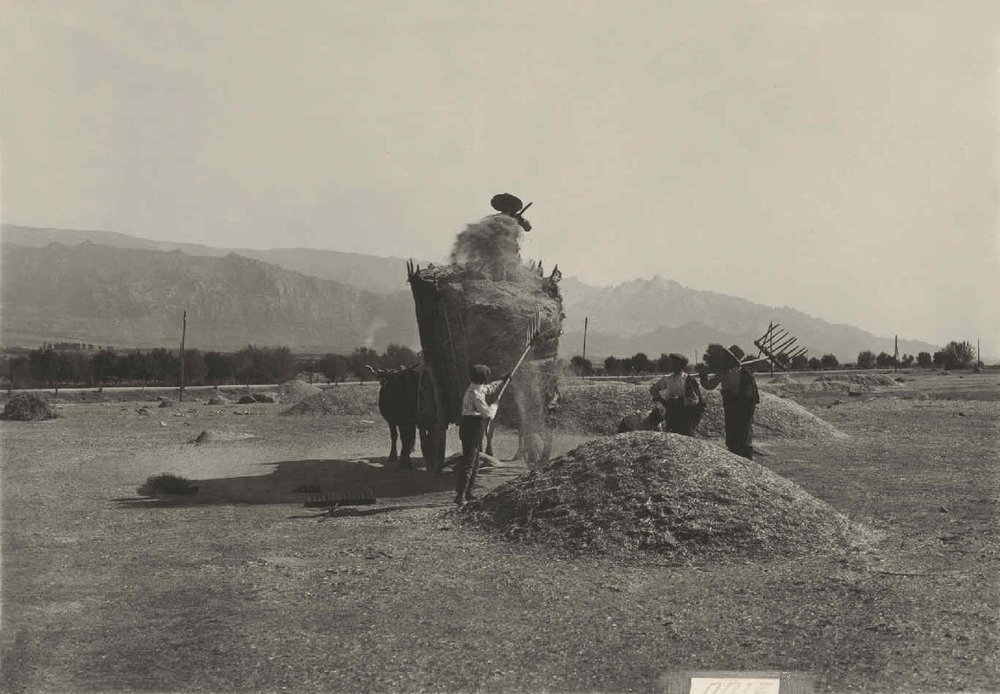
[113,458,455,508]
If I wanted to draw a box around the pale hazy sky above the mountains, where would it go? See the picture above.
[0,0,1000,354]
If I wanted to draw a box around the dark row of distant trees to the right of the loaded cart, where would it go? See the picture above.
[569,342,975,376]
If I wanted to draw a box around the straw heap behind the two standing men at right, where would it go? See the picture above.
[555,383,846,439]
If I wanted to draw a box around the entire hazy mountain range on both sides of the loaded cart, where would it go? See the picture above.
[0,224,938,362]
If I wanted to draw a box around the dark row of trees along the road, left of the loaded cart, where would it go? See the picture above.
[0,344,420,391]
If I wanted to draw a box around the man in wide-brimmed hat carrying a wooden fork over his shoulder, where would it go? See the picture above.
[699,345,760,460]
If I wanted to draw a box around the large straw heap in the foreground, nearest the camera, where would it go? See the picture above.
[460,432,857,562]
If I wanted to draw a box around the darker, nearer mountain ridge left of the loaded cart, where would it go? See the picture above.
[0,242,419,352]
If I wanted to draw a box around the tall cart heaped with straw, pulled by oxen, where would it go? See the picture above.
[407,261,563,472]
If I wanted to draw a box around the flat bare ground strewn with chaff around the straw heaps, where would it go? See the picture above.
[0,372,1000,692]
